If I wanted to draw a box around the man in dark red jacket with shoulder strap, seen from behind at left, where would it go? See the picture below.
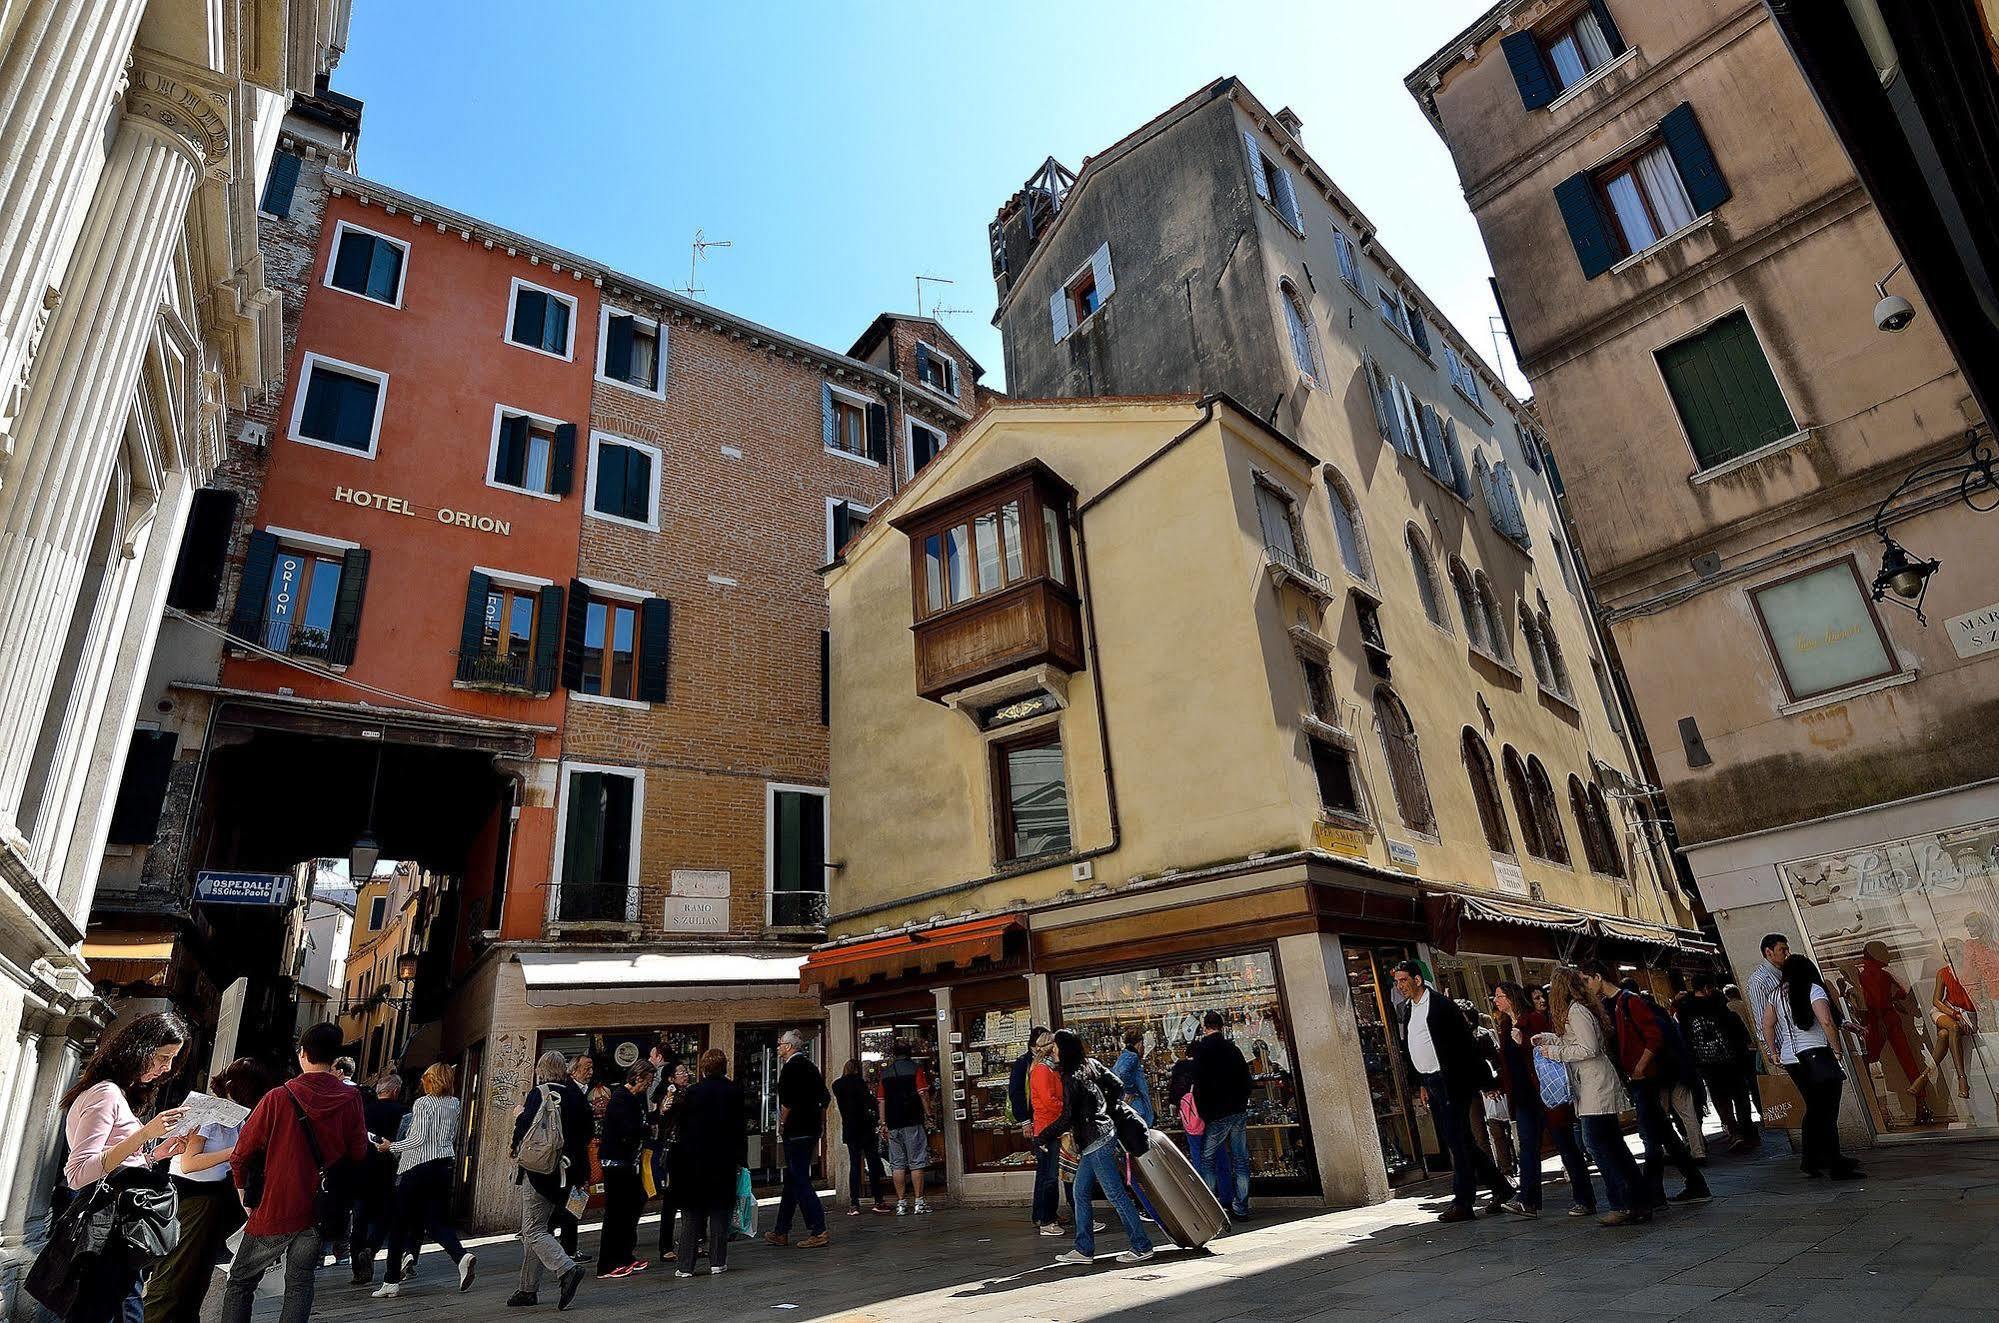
[222,1025,368,1323]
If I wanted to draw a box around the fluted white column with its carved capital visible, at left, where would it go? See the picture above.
[0,114,202,831]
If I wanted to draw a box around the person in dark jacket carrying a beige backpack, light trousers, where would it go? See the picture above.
[506,1051,590,1311]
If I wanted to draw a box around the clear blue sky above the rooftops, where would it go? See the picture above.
[334,0,1523,390]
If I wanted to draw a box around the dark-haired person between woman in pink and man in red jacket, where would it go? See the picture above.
[146,1057,272,1323]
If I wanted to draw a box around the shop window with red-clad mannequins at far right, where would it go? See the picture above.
[1779,821,1999,1133]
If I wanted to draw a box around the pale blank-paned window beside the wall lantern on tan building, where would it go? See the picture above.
[1749,556,1901,701]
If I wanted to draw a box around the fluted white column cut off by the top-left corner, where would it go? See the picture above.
[0,0,146,451]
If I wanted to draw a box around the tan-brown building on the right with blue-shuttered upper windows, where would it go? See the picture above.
[1407,0,1999,1137]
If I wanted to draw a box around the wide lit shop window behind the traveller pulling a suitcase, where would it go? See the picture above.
[1059,951,1319,1195]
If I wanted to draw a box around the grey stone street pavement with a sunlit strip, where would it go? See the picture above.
[210,1143,1999,1323]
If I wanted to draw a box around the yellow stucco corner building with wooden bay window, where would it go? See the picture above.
[806,78,1707,1205]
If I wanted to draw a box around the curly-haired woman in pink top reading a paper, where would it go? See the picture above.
[62,1011,194,1323]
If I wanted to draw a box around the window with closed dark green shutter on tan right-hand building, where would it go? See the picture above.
[1657,310,1797,468]
